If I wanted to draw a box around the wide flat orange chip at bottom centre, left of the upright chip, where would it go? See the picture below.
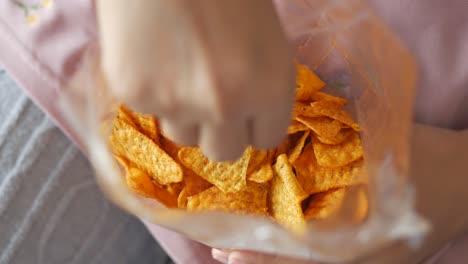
[187,183,268,215]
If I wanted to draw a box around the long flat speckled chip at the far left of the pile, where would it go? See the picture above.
[110,119,182,185]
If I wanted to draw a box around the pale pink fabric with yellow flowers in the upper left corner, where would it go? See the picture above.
[0,0,97,147]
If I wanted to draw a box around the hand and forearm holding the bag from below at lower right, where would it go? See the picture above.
[212,125,468,264]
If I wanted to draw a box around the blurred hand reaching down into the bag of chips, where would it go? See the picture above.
[97,0,295,160]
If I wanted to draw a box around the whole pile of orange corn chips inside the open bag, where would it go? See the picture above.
[110,65,368,230]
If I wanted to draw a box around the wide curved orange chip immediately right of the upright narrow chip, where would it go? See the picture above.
[294,144,367,194]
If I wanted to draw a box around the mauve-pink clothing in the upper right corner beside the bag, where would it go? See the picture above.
[369,0,468,128]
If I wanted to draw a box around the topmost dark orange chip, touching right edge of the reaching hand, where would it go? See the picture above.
[296,64,325,101]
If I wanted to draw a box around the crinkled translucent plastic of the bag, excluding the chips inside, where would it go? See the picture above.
[60,0,429,262]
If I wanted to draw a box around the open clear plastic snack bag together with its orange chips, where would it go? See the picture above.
[60,0,428,262]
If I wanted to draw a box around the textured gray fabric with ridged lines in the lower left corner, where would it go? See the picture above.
[0,69,171,264]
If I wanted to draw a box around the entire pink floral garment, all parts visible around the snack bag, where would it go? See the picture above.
[0,0,468,263]
